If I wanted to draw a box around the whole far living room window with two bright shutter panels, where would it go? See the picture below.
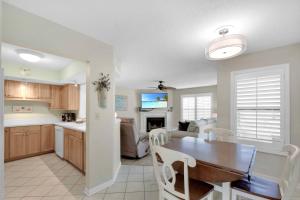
[181,94,212,121]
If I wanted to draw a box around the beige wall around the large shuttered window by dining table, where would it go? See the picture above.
[217,44,300,194]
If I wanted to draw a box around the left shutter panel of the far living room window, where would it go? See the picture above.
[182,97,196,120]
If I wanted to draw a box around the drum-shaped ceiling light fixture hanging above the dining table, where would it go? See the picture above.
[205,28,247,60]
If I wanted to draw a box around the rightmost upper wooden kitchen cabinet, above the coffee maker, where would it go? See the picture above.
[61,84,79,110]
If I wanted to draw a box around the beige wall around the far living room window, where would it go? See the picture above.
[172,85,217,128]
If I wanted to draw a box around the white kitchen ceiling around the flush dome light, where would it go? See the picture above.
[1,43,73,70]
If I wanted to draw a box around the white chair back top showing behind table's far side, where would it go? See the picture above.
[204,128,235,142]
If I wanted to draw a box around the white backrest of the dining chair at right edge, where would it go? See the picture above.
[280,144,300,200]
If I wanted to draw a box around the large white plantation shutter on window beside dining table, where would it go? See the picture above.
[235,72,283,143]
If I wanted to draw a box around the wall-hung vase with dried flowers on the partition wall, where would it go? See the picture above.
[93,73,110,108]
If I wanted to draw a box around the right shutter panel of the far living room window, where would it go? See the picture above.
[197,96,212,120]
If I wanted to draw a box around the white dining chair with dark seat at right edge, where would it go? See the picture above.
[231,145,300,200]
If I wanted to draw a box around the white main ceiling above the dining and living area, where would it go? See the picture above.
[6,0,300,88]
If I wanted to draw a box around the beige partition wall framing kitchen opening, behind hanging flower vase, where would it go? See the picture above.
[3,4,120,195]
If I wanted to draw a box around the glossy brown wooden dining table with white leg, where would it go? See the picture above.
[163,137,256,200]
